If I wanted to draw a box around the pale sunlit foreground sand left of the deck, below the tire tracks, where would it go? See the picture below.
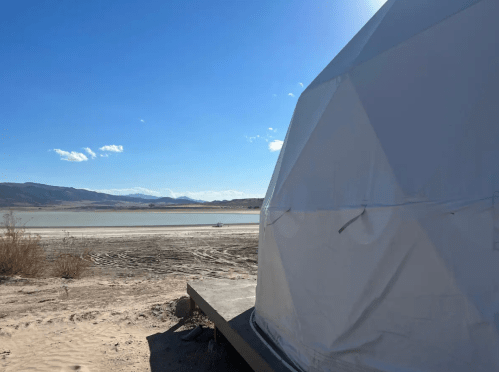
[0,278,185,371]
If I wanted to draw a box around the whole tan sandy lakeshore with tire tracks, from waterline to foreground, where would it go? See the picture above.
[0,225,258,372]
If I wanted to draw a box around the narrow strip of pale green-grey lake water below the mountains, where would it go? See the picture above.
[0,211,260,227]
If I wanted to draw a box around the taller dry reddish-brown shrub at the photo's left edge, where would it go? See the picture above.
[0,211,45,277]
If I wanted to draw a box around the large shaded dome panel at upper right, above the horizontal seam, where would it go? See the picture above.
[350,2,499,200]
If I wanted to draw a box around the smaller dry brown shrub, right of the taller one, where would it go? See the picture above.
[53,232,92,279]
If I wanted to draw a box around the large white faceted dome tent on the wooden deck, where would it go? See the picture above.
[254,0,499,372]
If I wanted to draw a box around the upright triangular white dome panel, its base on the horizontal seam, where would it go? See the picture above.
[272,75,403,211]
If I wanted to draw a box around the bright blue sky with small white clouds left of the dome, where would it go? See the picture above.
[0,0,384,200]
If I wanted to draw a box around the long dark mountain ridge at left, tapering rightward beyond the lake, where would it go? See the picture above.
[0,182,198,207]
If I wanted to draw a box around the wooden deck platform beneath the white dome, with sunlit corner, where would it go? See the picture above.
[187,279,295,372]
